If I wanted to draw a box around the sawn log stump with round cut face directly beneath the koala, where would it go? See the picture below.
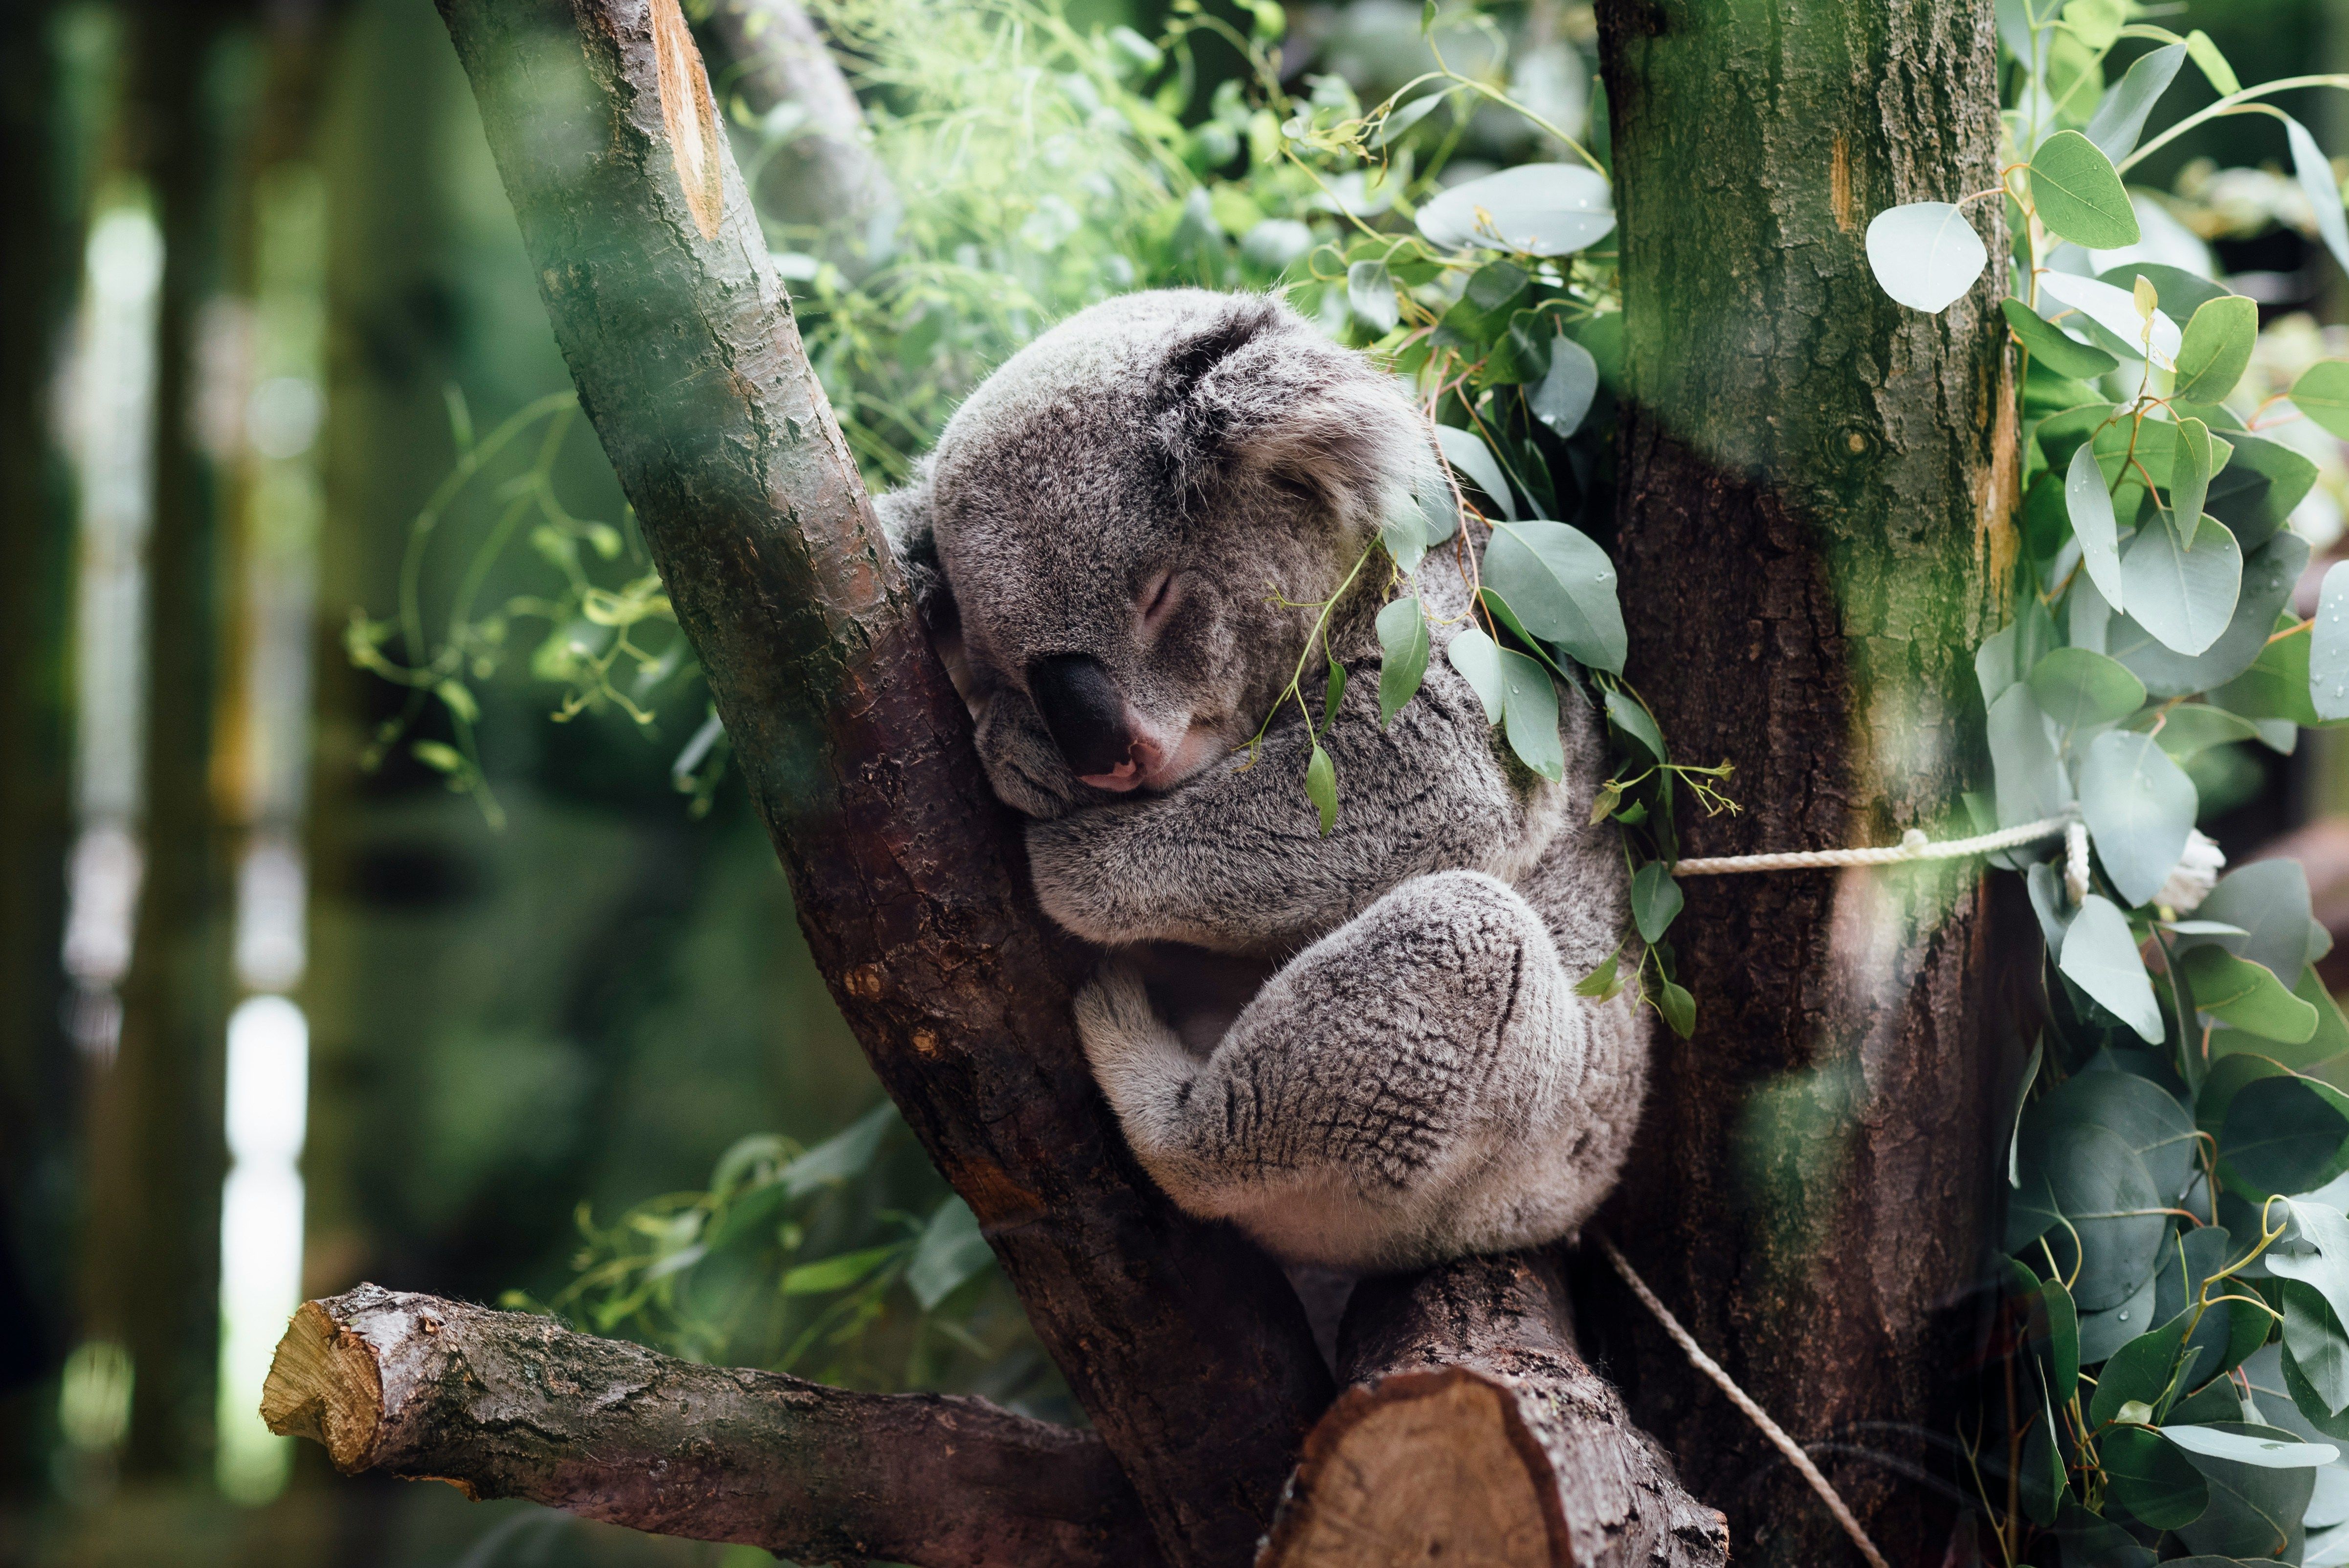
[1257,1254,1729,1568]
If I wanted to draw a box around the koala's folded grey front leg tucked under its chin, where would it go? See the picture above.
[1026,666,1529,953]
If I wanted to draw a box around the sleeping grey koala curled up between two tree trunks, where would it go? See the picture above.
[881,289,1647,1270]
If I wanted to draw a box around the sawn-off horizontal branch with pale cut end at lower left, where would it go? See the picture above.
[261,1284,1158,1568]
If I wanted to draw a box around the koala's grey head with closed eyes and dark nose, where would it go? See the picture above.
[930,291,1423,817]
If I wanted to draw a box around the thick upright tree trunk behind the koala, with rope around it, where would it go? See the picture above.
[1586,0,2016,1563]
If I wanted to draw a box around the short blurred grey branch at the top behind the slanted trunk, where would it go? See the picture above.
[709,0,902,275]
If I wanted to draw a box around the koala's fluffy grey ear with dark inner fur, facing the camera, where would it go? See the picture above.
[1151,296,1433,533]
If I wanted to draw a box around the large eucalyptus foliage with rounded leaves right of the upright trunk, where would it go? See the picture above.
[1870,0,2349,1568]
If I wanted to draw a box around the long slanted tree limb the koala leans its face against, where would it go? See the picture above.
[439,0,1330,1568]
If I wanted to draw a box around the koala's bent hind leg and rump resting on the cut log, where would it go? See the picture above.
[1076,871,1606,1267]
